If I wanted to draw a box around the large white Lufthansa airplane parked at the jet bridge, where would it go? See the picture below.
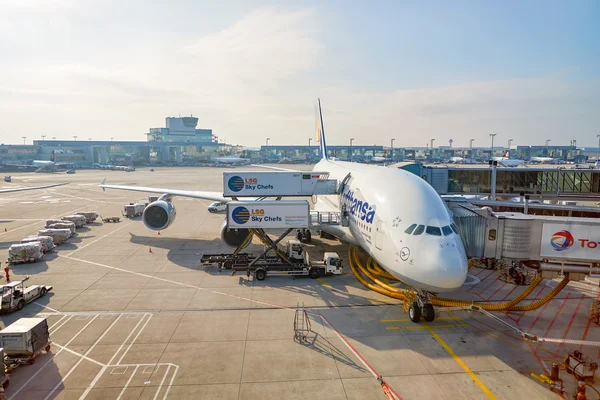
[100,100,468,322]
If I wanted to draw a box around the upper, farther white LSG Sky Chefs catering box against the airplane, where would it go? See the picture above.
[223,171,337,197]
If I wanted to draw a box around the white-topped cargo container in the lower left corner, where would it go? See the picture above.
[0,318,50,357]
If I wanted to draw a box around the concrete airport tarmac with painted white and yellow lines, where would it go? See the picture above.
[0,166,600,400]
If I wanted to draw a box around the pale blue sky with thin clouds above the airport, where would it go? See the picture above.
[0,0,600,147]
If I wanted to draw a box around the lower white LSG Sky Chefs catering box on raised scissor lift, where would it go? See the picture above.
[227,200,310,229]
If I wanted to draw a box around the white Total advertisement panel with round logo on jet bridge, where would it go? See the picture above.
[540,223,600,261]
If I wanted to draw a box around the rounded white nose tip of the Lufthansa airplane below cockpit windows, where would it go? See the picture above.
[426,244,468,292]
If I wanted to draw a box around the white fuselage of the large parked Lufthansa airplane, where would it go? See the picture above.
[314,160,467,292]
